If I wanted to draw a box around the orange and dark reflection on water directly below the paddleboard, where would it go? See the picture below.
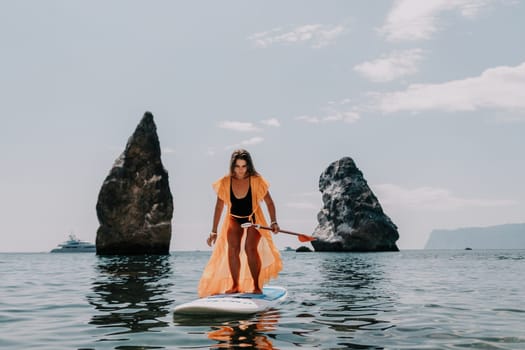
[173,310,280,349]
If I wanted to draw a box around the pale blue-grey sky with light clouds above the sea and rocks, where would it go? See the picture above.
[0,0,525,252]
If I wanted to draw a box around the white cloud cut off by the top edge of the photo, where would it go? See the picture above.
[378,0,494,41]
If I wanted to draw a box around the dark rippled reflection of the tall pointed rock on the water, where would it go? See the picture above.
[87,255,173,335]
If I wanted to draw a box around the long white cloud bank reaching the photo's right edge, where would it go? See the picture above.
[372,62,525,113]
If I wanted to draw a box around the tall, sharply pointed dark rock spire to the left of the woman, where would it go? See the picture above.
[96,112,173,255]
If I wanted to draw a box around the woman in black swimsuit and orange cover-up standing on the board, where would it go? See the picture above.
[199,149,282,297]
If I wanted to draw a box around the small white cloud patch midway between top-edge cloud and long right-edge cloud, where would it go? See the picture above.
[354,49,423,83]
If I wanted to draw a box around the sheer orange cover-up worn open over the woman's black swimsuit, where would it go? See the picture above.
[199,175,282,298]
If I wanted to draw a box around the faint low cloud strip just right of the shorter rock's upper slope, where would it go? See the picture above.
[374,184,518,211]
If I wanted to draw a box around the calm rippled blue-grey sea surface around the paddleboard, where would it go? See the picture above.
[0,250,525,349]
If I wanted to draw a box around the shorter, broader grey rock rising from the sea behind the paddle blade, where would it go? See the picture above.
[312,157,399,252]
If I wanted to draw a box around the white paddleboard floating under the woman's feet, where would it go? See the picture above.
[173,286,288,315]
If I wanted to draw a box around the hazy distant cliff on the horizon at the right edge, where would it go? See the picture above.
[425,224,525,249]
